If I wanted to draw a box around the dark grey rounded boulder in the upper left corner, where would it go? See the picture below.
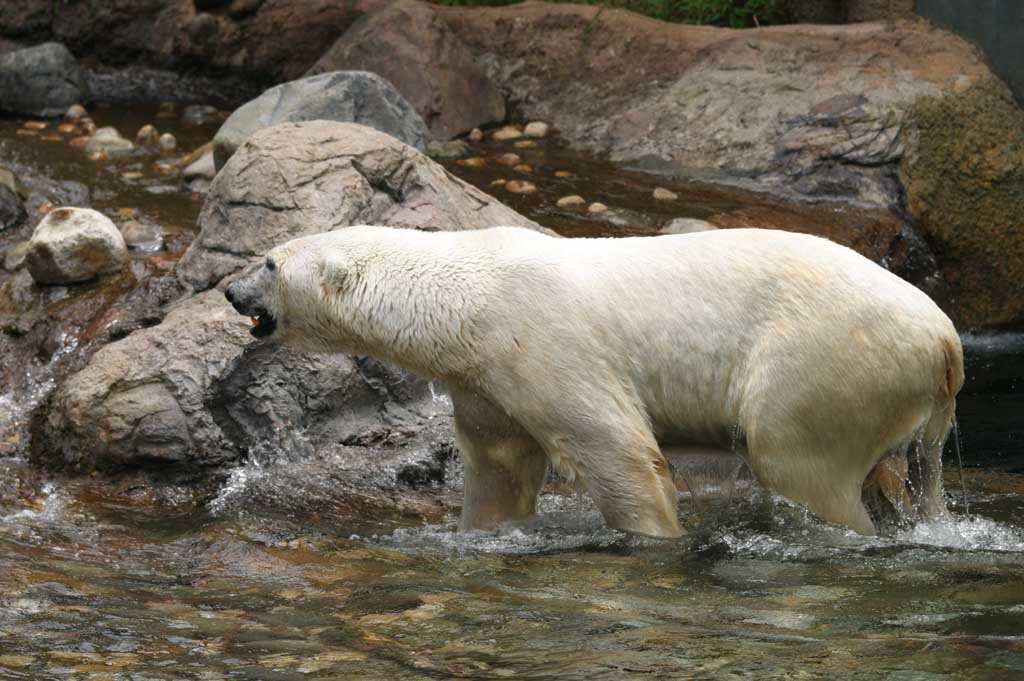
[0,43,88,117]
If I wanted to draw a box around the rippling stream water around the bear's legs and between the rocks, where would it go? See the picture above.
[0,109,1024,681]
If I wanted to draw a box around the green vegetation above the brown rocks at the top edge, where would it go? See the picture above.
[434,0,792,29]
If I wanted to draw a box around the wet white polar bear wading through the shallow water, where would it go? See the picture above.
[225,226,964,537]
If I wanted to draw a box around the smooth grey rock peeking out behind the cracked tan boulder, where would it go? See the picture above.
[213,72,427,170]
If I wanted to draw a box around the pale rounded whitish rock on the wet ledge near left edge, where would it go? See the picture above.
[26,208,128,285]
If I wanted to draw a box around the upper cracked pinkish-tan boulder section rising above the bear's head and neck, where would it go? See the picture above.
[177,121,540,290]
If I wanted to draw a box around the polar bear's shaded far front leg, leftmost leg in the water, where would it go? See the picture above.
[452,389,548,529]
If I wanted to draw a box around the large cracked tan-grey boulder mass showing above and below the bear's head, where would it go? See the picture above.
[32,121,540,473]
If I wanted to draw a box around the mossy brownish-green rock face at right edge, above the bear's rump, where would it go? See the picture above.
[899,78,1024,329]
